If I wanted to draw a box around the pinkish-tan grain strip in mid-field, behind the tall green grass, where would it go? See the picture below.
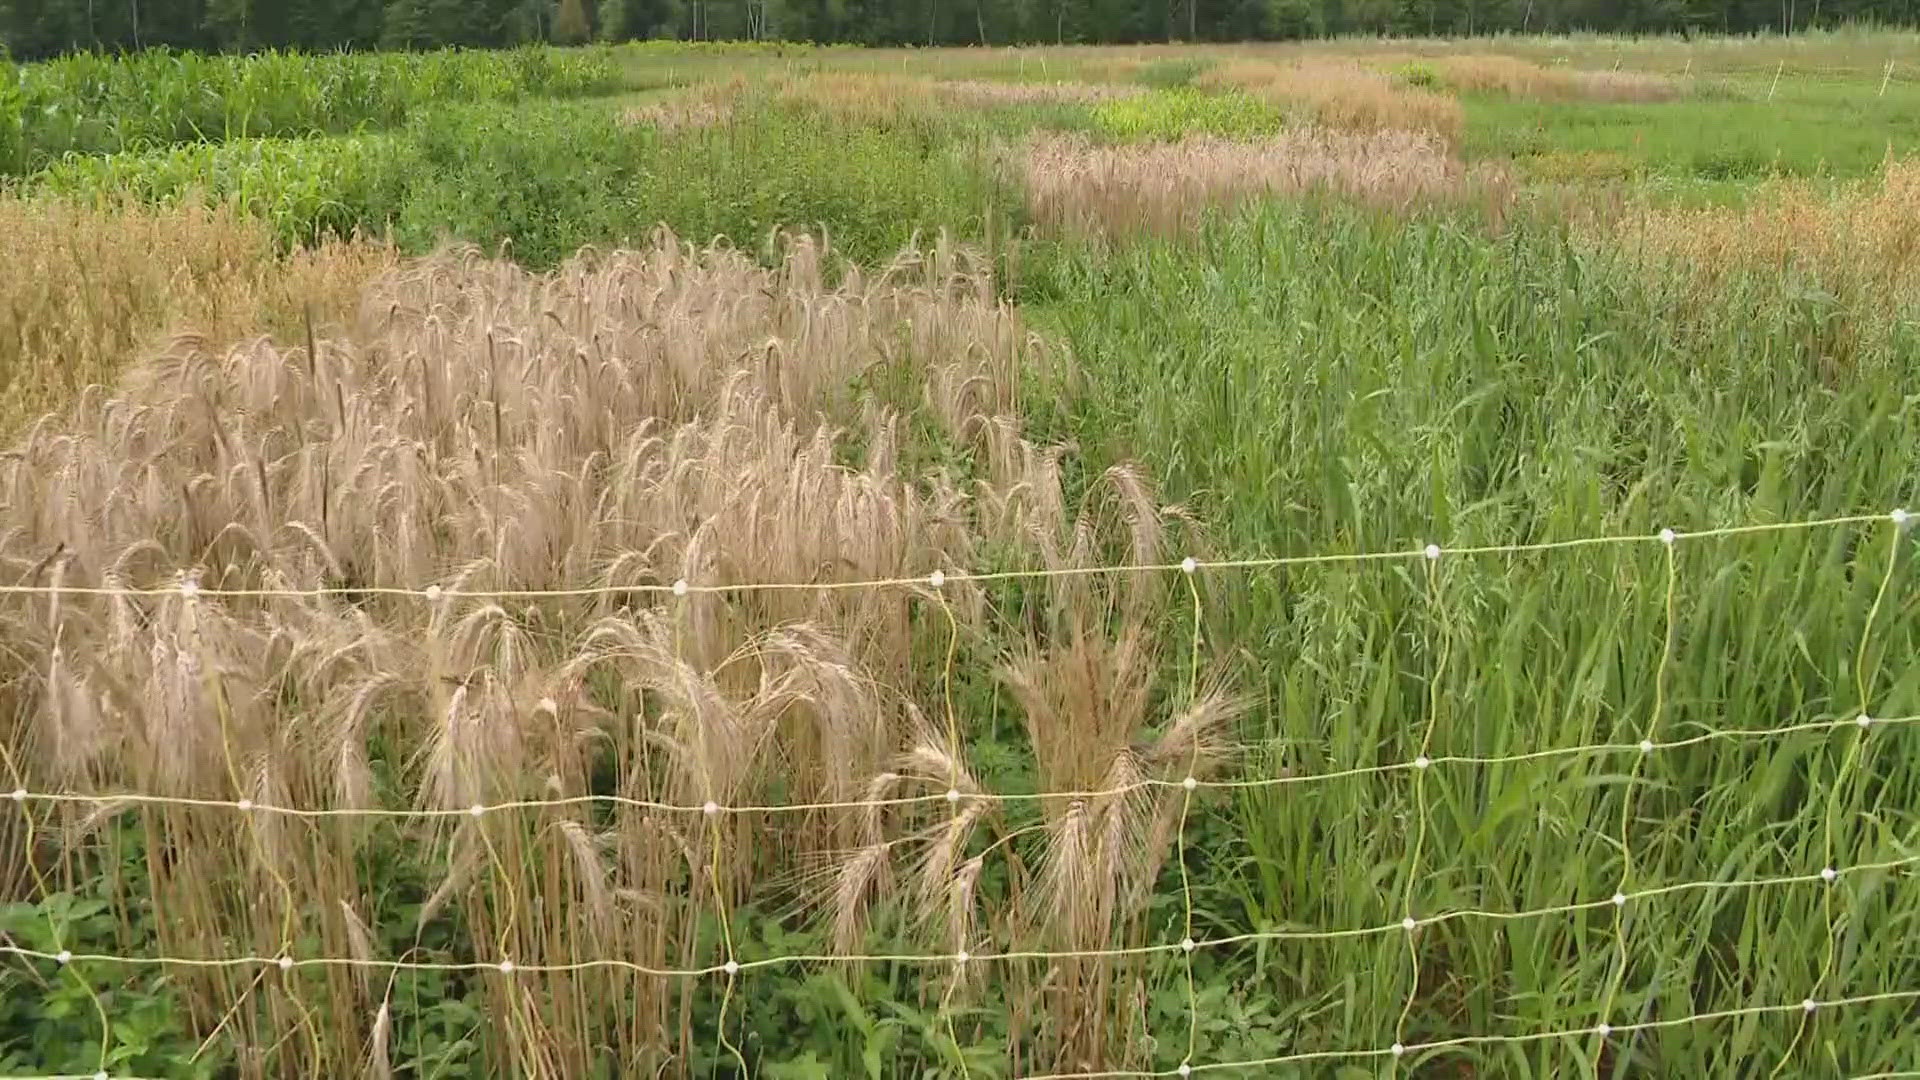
[1025,129,1507,234]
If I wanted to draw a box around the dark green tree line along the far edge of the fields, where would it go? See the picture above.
[0,0,1920,60]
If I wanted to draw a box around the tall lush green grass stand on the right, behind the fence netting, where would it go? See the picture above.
[1029,206,1920,1076]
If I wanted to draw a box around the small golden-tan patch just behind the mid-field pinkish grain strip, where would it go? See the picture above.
[1196,58,1465,142]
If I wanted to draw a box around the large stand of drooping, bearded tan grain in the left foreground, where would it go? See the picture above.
[0,224,1213,1076]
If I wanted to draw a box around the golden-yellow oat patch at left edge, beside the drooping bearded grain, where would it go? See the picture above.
[0,196,396,432]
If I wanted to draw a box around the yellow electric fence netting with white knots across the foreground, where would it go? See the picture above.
[0,511,1920,1080]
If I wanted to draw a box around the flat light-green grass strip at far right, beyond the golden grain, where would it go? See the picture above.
[1463,77,1920,181]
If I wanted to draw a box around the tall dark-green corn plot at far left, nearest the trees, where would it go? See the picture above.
[0,46,618,177]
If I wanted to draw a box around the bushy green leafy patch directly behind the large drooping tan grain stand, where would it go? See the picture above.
[399,96,1014,265]
